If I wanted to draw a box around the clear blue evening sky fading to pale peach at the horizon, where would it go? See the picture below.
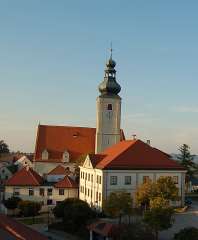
[0,0,198,154]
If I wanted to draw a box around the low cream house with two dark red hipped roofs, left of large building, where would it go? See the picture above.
[4,167,78,210]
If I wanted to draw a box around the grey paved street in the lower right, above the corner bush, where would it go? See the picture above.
[159,201,198,240]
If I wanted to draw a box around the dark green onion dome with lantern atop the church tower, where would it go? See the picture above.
[98,55,121,95]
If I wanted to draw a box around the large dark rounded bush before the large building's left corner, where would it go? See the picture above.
[53,198,96,232]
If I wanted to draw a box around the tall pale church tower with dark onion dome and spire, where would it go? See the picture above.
[95,49,121,153]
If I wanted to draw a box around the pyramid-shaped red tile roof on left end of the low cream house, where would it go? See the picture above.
[5,167,43,186]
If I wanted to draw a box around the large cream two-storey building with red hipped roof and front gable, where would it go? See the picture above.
[79,140,186,210]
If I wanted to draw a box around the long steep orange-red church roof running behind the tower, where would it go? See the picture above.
[35,125,125,162]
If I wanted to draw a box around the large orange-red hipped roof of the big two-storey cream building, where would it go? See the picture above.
[92,140,185,170]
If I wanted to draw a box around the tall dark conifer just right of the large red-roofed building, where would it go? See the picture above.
[177,144,197,177]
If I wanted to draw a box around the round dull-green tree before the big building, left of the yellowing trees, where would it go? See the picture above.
[104,191,132,222]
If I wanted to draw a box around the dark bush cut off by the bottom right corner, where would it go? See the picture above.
[174,227,198,240]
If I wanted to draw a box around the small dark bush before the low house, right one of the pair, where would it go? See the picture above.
[18,201,41,217]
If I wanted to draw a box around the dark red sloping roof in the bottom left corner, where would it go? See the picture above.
[0,214,48,240]
